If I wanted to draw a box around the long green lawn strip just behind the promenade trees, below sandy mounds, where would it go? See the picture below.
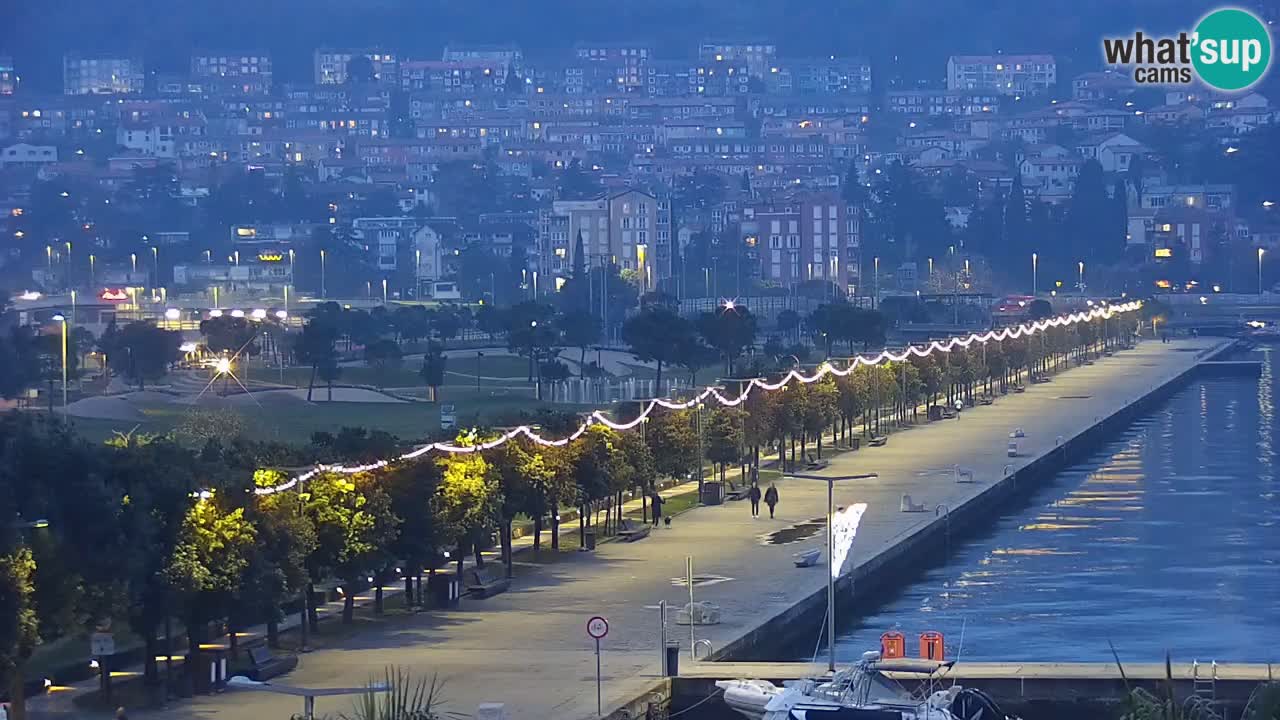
[73,386,560,443]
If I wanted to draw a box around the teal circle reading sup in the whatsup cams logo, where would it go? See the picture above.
[1192,8,1271,90]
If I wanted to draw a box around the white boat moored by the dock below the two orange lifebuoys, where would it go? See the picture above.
[716,651,1009,720]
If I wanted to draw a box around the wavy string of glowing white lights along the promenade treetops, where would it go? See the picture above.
[253,300,1142,495]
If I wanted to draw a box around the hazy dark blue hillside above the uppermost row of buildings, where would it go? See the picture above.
[0,0,1228,90]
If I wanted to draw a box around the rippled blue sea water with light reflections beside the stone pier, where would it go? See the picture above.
[837,351,1280,662]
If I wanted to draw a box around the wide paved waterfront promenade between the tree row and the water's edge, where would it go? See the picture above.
[24,338,1219,720]
